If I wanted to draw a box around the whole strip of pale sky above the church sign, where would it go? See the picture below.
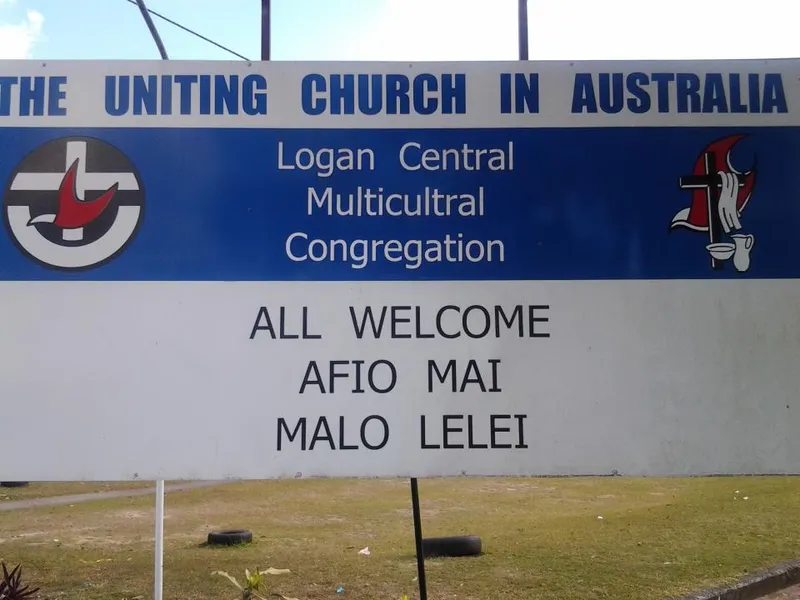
[0,0,800,61]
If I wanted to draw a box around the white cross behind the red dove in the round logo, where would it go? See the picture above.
[11,141,139,241]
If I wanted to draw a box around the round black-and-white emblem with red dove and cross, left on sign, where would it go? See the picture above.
[3,137,144,271]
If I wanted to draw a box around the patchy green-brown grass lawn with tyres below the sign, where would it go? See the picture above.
[0,477,800,600]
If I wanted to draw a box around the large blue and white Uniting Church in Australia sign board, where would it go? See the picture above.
[0,60,800,480]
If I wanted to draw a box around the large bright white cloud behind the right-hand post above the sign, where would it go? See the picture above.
[326,0,800,61]
